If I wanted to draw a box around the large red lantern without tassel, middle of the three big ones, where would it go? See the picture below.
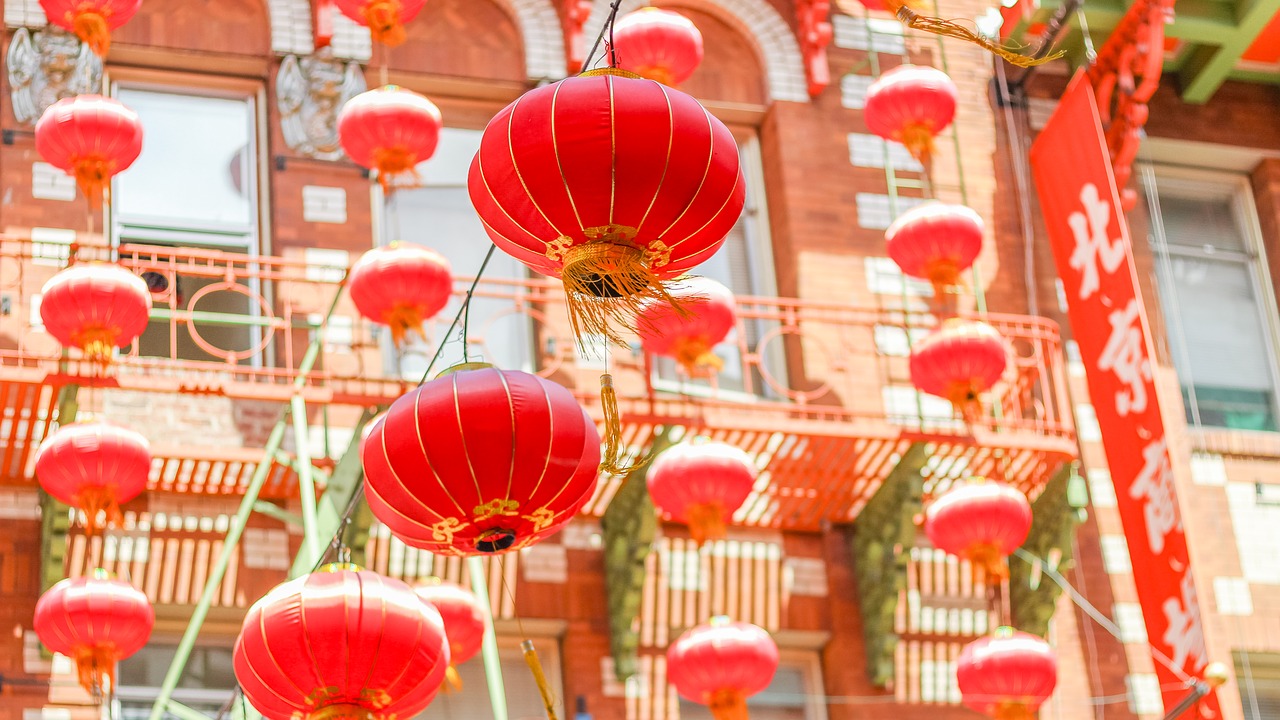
[362,363,600,555]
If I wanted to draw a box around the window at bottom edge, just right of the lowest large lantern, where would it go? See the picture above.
[417,637,560,720]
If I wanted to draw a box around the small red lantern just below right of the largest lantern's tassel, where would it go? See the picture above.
[636,277,737,375]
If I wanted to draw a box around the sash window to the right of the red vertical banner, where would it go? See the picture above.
[1143,165,1280,430]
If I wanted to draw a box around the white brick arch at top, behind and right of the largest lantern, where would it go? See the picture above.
[582,0,809,102]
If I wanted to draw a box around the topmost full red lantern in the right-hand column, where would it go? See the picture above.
[863,65,957,164]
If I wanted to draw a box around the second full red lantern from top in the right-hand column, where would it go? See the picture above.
[884,202,983,292]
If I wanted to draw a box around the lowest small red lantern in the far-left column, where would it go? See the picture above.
[32,569,156,697]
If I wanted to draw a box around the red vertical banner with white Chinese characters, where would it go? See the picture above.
[1030,72,1221,717]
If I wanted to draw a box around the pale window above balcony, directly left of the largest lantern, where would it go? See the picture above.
[383,128,534,380]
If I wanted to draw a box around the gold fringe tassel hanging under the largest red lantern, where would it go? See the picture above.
[558,239,689,350]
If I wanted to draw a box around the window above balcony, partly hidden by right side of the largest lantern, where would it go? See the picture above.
[654,136,786,396]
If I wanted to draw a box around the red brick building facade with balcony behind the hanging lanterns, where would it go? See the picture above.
[0,0,1280,720]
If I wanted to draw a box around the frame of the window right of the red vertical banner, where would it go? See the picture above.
[1138,160,1280,433]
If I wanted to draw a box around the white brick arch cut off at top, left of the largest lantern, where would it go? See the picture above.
[267,0,564,79]
